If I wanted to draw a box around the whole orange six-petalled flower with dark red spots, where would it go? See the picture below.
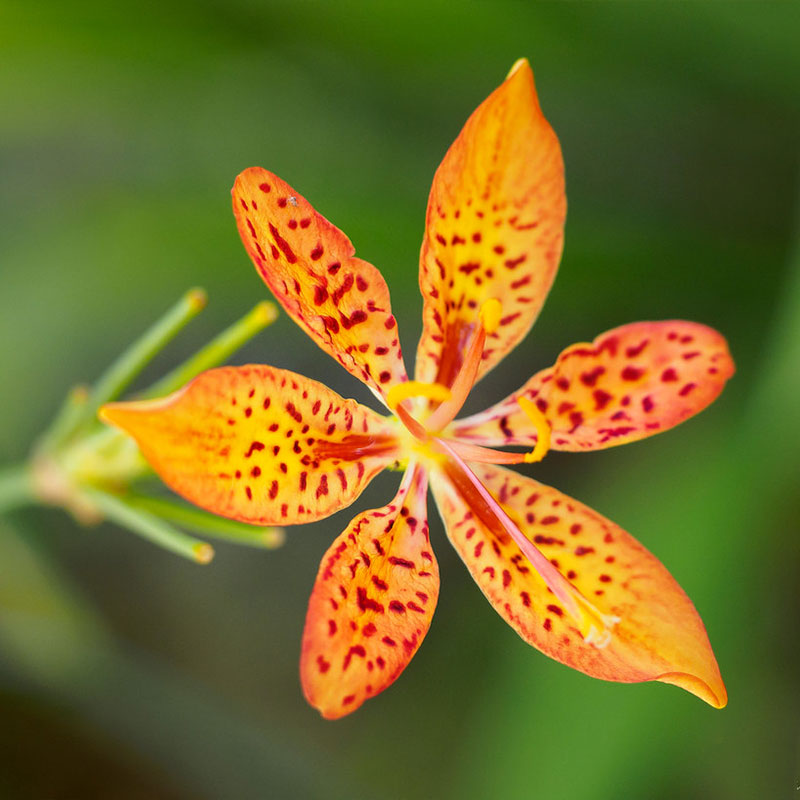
[101,59,733,718]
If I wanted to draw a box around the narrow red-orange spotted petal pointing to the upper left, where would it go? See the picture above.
[232,167,406,399]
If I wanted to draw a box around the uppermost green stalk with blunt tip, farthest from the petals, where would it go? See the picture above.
[86,289,206,421]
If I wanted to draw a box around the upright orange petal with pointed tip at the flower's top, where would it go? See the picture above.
[416,60,566,386]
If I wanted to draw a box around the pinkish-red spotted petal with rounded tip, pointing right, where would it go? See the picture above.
[452,320,734,451]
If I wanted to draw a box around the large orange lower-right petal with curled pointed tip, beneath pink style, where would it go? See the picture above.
[431,464,727,708]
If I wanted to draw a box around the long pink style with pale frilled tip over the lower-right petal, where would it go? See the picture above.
[434,438,620,649]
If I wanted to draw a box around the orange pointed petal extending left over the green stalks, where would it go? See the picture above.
[101,365,397,525]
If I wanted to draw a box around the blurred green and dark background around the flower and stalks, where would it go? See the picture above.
[0,0,800,800]
